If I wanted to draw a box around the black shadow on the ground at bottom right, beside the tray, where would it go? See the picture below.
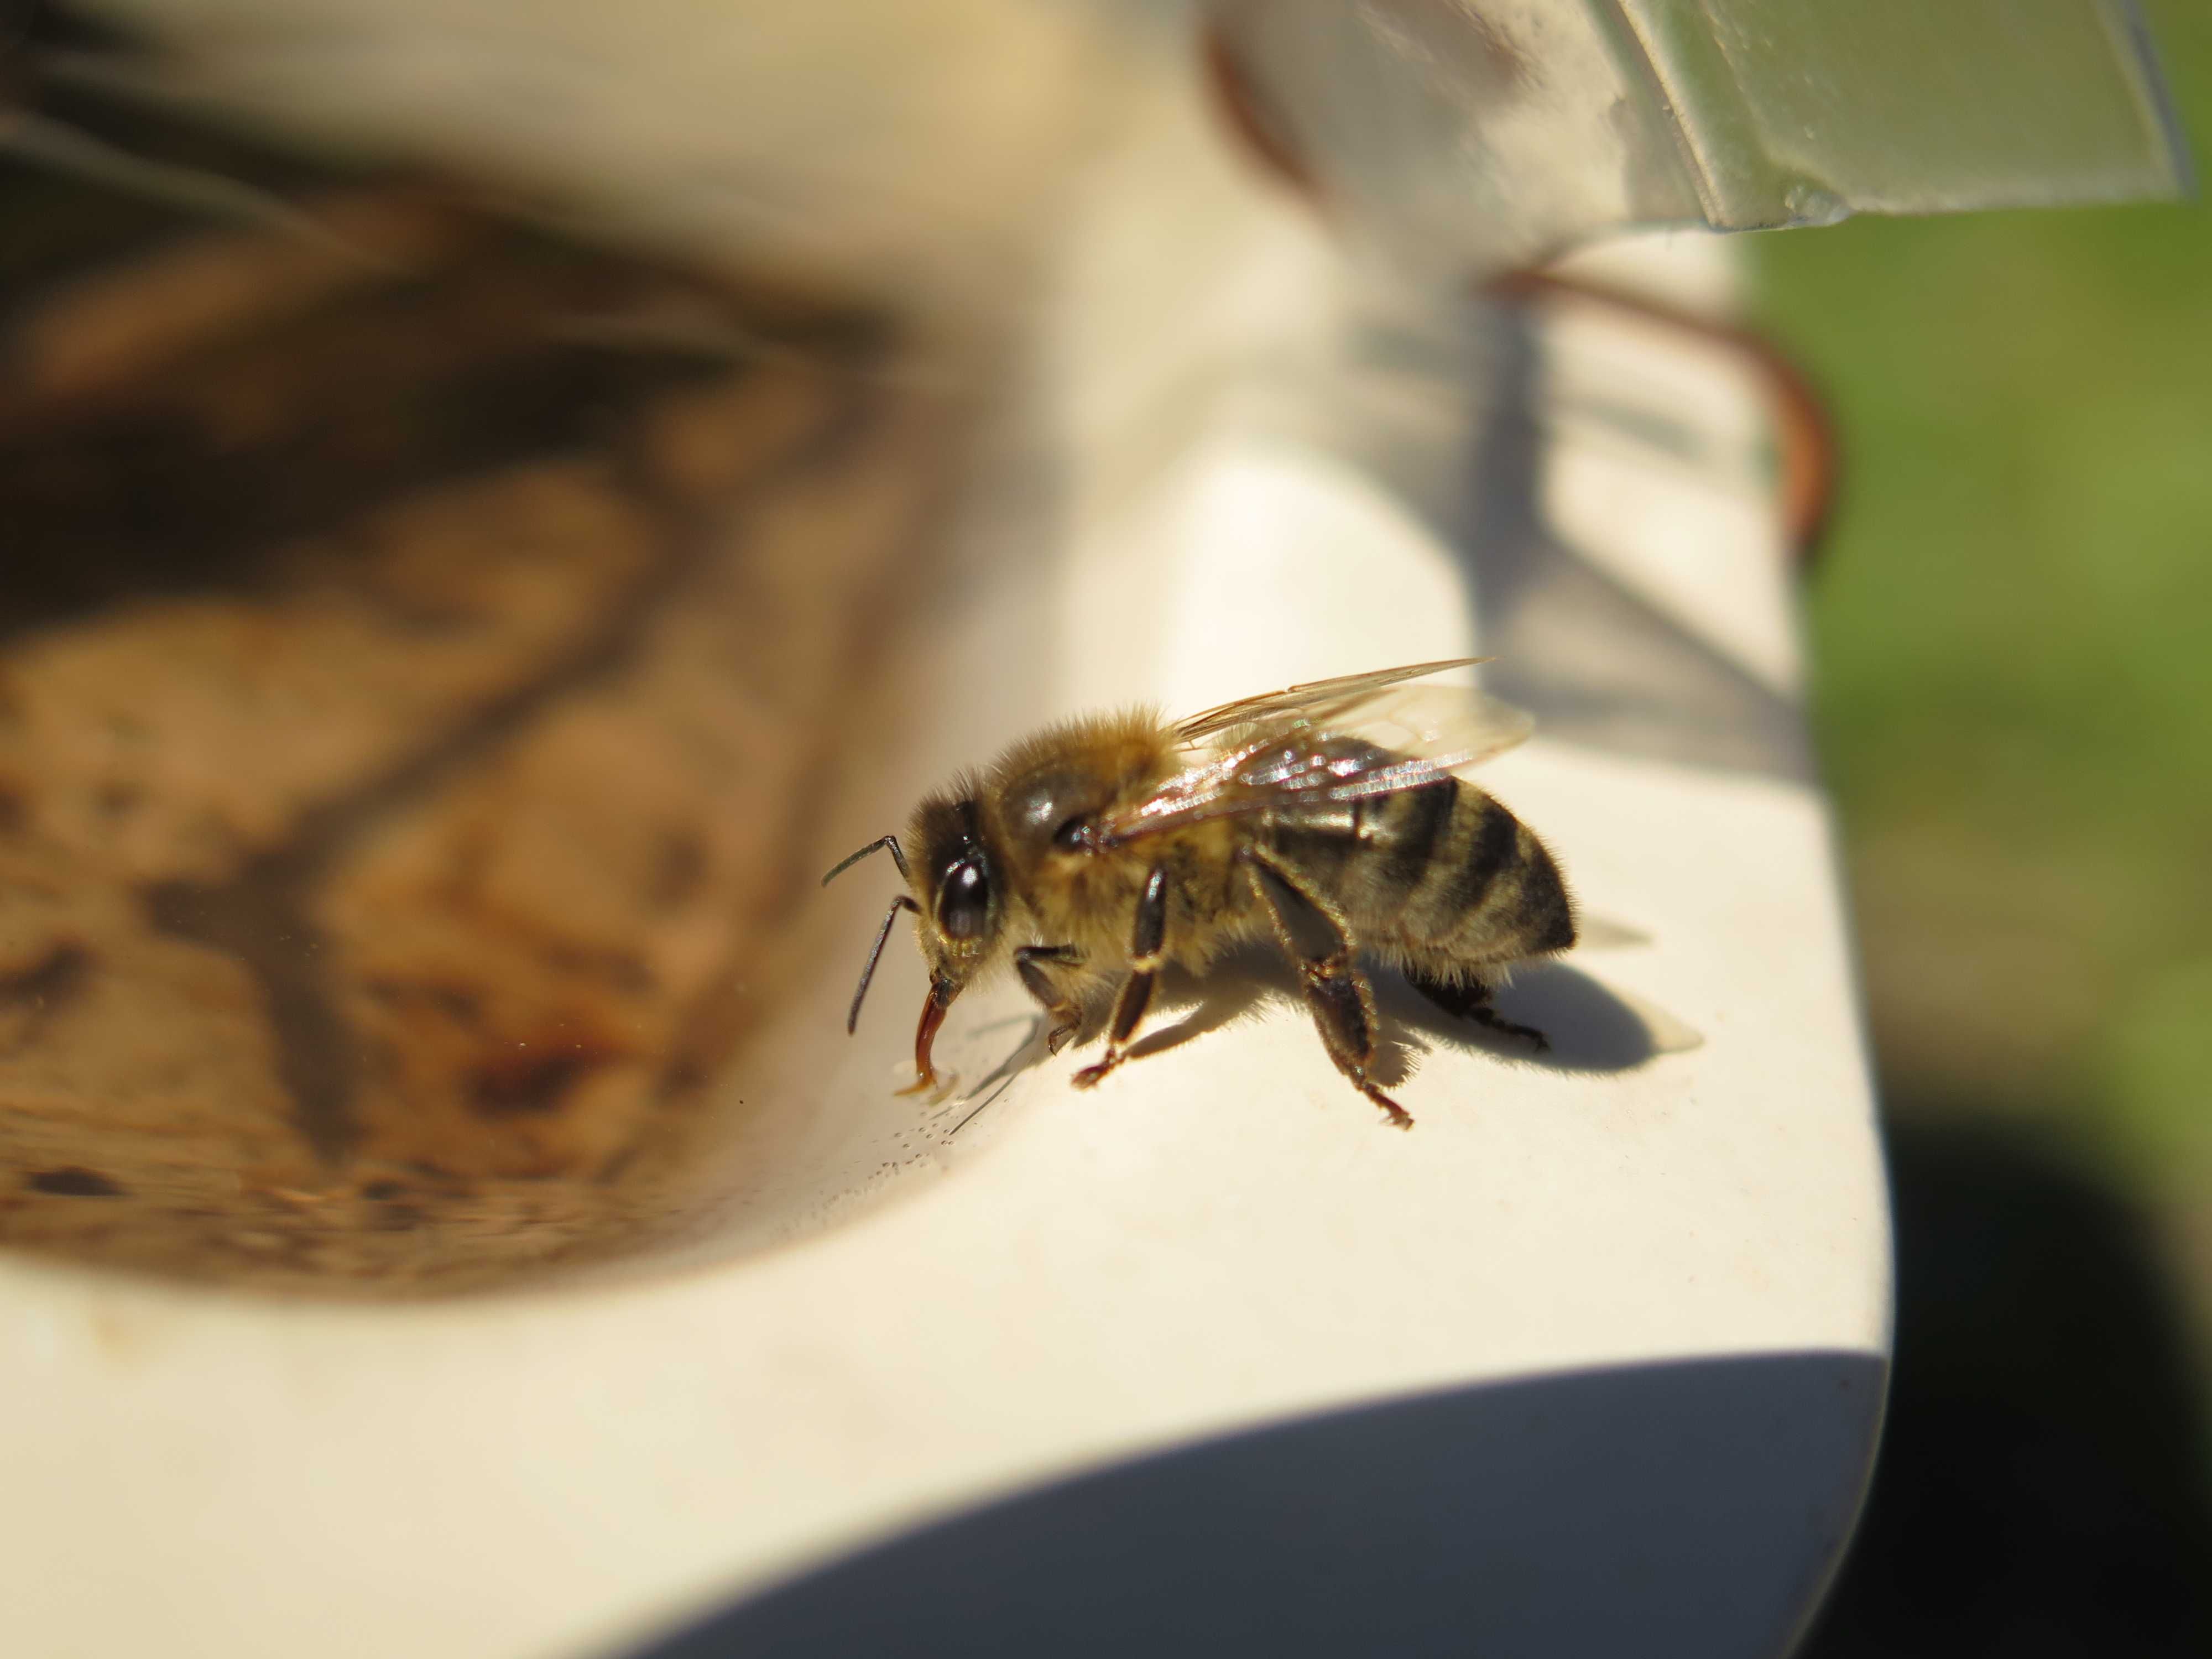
[1805,1121,2212,1659]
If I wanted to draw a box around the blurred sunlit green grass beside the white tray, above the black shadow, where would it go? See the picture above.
[1752,0,2212,1310]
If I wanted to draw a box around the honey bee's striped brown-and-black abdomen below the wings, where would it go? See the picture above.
[1263,779,1575,969]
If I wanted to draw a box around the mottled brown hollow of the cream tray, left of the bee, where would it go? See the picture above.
[0,192,953,1294]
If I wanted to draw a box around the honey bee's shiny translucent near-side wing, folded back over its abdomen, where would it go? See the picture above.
[1095,681,1535,843]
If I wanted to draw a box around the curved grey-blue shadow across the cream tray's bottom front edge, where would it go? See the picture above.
[639,1354,1882,1659]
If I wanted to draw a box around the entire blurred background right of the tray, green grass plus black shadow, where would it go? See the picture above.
[1754,0,2212,1652]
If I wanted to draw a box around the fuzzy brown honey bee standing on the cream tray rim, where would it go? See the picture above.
[823,657,1575,1128]
